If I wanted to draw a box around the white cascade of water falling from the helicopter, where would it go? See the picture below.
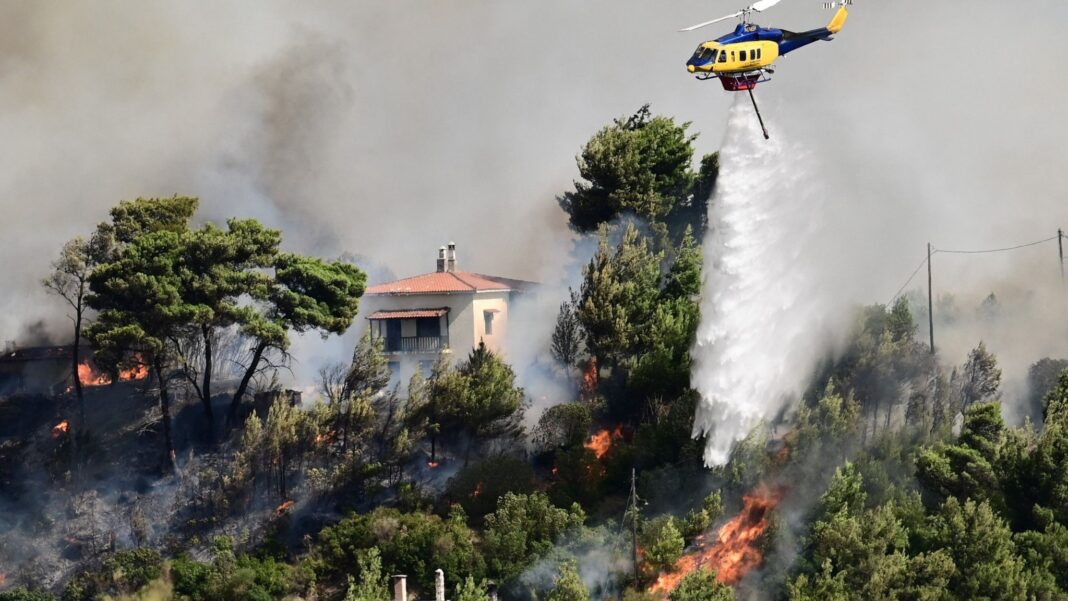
[691,94,835,465]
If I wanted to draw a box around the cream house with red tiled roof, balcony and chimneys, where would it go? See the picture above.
[361,242,536,381]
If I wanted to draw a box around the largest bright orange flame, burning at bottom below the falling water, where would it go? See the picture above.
[649,486,784,596]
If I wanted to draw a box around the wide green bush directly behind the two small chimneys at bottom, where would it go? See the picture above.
[311,507,485,592]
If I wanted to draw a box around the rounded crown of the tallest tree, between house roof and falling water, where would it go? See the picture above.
[560,106,694,232]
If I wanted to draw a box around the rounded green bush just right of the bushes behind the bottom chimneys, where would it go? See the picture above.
[483,492,585,581]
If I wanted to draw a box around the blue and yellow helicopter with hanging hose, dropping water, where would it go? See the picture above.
[679,0,853,140]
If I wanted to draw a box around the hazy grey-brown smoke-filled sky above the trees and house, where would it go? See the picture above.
[0,0,1068,367]
